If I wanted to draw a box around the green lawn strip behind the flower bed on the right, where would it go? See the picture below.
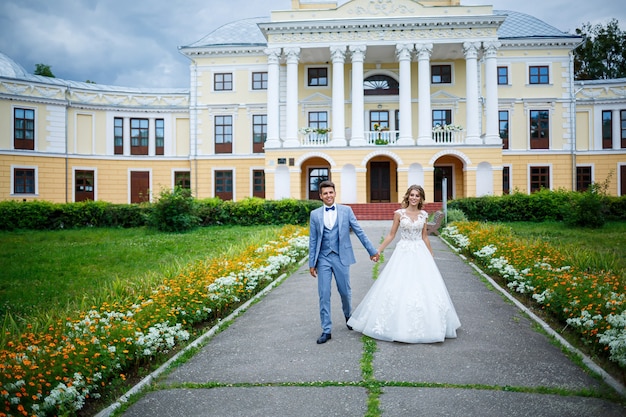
[503,222,626,279]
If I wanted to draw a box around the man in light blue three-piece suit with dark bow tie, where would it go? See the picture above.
[309,181,379,345]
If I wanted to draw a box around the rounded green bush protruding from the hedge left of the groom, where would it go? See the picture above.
[147,186,200,232]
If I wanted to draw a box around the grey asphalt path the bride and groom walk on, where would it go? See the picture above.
[113,221,626,417]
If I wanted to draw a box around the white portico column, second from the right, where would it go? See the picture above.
[463,42,482,144]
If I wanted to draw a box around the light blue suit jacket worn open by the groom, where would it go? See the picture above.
[309,204,377,268]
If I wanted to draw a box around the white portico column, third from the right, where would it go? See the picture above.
[416,43,434,145]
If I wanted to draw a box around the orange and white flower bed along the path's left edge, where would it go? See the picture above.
[0,226,308,417]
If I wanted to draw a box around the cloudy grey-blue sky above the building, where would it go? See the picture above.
[0,0,626,88]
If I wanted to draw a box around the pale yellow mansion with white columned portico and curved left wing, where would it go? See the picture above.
[0,0,626,204]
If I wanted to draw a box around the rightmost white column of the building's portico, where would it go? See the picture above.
[483,41,502,145]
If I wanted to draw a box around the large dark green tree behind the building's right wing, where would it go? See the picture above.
[574,19,626,80]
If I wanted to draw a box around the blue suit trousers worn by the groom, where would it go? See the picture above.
[317,252,352,333]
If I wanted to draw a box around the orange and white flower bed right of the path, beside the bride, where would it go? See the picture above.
[441,222,626,369]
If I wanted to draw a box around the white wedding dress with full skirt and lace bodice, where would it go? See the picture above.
[348,209,461,343]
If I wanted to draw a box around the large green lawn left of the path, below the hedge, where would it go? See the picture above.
[0,226,279,331]
